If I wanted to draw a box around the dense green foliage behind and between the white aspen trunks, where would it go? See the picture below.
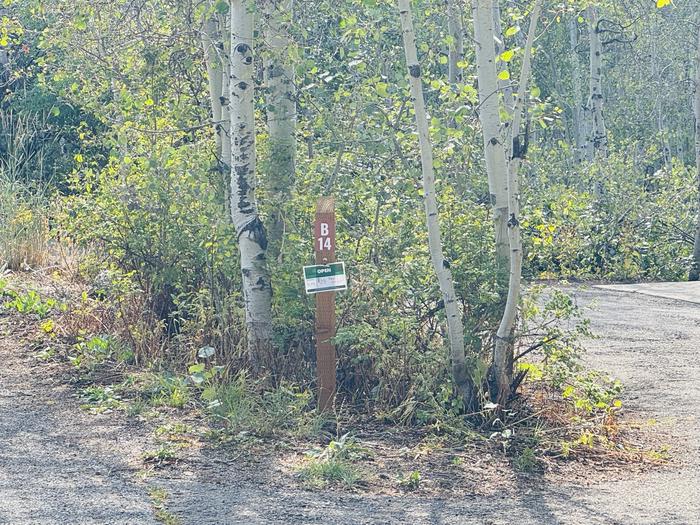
[0,0,697,422]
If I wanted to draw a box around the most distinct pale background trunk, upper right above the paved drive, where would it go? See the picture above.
[586,6,608,160]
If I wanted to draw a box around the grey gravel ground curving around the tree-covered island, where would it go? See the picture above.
[0,282,700,525]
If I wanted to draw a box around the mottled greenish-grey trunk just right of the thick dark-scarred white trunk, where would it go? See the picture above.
[264,0,297,258]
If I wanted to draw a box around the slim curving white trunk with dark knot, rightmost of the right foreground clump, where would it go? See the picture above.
[492,0,542,405]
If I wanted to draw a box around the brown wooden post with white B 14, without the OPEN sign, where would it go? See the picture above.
[314,197,336,411]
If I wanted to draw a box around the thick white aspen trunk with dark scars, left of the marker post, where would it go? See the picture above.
[229,0,272,373]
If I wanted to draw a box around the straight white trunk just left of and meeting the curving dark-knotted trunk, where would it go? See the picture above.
[472,0,509,262]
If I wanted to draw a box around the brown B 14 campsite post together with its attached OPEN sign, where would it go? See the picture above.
[304,197,348,411]
